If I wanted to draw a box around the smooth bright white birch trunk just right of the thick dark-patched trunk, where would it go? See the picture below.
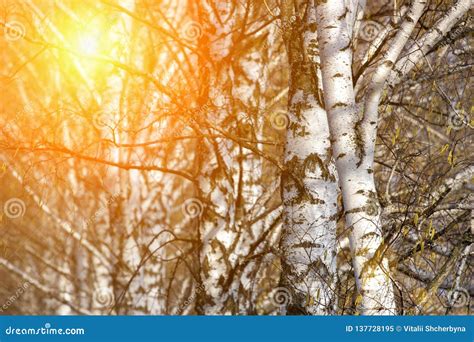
[317,0,396,315]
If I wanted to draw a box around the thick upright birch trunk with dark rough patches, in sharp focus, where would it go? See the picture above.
[281,1,337,315]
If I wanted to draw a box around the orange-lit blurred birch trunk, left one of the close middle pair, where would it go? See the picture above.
[196,1,238,315]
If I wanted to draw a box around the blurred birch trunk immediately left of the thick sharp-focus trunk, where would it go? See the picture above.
[231,17,281,314]
